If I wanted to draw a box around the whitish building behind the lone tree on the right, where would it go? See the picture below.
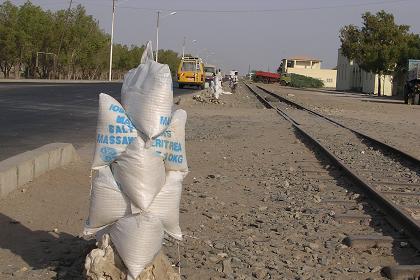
[336,49,392,96]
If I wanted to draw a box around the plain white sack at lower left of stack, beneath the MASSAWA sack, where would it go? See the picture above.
[84,166,131,234]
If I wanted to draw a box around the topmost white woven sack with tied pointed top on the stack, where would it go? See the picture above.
[121,42,173,141]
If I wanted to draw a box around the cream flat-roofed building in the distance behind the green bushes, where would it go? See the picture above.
[281,56,337,88]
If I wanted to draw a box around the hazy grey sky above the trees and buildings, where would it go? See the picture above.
[12,0,420,73]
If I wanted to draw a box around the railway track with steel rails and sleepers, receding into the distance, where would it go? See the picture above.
[246,84,420,279]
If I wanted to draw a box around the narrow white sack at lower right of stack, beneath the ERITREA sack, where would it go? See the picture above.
[148,171,187,240]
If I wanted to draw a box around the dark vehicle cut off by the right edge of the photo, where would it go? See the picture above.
[404,59,420,105]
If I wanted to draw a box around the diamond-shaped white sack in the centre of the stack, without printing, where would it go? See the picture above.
[111,137,165,210]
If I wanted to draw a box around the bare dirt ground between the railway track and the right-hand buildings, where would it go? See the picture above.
[260,84,420,158]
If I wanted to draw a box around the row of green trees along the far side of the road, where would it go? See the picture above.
[0,0,179,79]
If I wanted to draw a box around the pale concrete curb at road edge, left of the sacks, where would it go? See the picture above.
[0,143,79,198]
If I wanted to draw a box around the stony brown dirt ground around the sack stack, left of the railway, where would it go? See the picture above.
[0,85,418,280]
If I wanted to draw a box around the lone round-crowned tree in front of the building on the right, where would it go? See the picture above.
[340,10,409,96]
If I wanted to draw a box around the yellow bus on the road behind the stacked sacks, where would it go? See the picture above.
[177,57,206,89]
